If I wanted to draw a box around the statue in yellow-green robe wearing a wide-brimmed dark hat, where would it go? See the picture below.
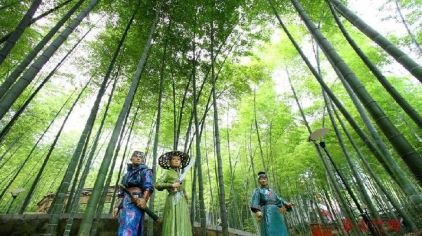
[155,151,192,236]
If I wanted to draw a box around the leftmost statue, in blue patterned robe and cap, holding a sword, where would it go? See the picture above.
[113,151,154,236]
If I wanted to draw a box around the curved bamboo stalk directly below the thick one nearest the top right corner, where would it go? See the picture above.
[326,0,422,128]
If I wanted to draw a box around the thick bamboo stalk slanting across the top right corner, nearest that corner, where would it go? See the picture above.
[329,0,422,82]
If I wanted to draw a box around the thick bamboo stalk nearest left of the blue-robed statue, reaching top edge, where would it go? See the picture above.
[78,1,161,232]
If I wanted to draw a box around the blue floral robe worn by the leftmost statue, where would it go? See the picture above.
[118,164,154,236]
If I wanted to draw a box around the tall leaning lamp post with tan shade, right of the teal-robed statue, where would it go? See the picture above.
[308,128,381,235]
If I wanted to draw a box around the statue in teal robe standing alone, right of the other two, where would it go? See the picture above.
[250,172,292,236]
